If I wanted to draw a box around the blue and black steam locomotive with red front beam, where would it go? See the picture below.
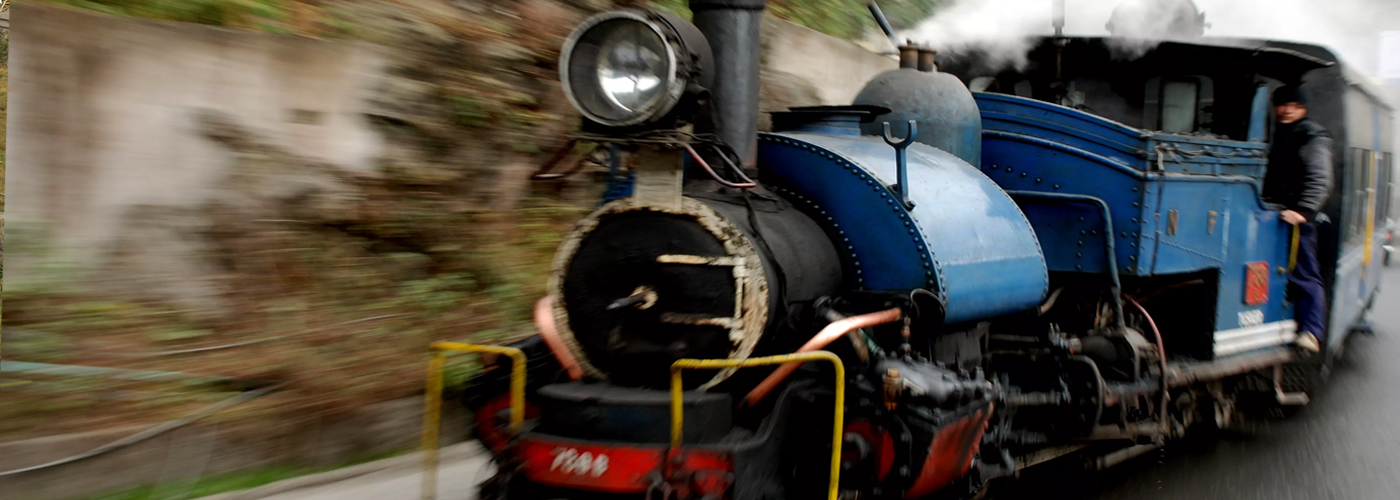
[468,0,1393,500]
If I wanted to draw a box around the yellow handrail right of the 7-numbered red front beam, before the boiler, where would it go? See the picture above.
[671,350,846,500]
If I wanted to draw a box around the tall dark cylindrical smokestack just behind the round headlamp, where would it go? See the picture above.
[690,0,767,165]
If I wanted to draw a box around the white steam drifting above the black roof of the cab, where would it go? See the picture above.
[900,0,1400,74]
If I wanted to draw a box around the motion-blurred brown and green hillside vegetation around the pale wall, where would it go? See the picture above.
[0,0,607,441]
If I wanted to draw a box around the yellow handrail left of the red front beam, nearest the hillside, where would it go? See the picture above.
[423,342,525,500]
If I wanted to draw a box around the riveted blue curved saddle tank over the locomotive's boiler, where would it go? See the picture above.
[759,133,1049,322]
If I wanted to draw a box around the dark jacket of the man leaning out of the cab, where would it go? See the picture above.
[1264,118,1333,221]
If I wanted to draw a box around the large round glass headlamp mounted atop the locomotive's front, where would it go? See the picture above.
[559,10,711,127]
